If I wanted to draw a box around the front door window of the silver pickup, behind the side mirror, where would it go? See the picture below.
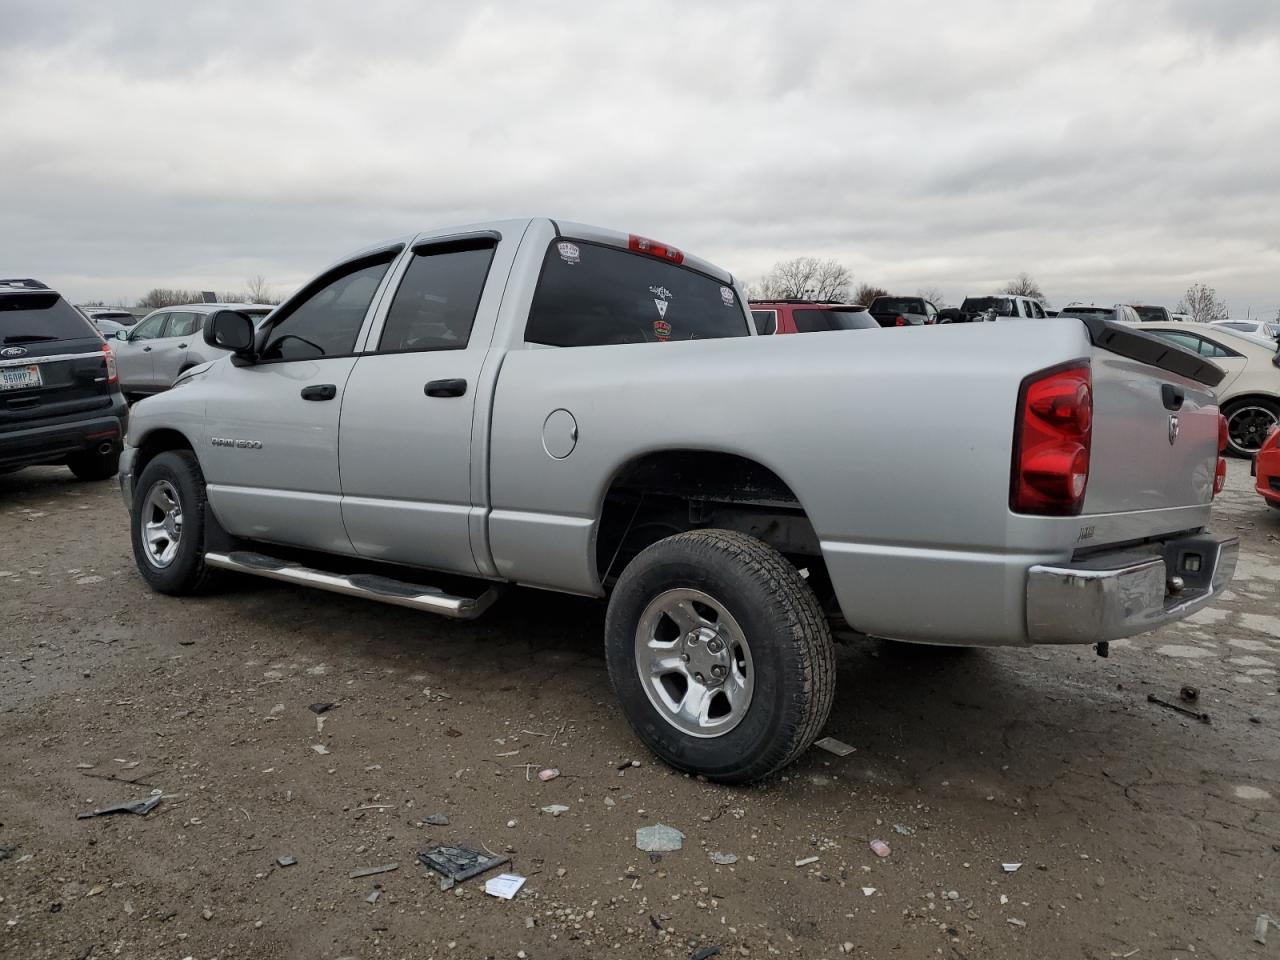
[262,251,398,360]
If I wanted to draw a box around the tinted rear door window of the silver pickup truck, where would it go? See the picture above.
[378,239,495,352]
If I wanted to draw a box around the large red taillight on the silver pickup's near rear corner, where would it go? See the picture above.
[1009,366,1093,516]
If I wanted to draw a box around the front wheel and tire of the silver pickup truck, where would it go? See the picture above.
[129,451,215,596]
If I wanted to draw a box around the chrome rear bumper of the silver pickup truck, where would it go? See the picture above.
[1027,536,1240,644]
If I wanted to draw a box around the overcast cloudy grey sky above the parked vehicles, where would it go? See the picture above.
[0,0,1280,316]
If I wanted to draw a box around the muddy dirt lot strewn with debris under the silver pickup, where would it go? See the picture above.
[0,462,1280,960]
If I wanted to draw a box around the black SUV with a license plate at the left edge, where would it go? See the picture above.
[0,280,129,480]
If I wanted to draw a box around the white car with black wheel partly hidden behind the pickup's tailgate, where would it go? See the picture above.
[1139,321,1280,457]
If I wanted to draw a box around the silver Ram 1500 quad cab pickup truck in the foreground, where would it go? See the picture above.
[120,219,1236,782]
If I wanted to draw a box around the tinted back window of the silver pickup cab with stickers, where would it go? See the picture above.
[525,239,750,347]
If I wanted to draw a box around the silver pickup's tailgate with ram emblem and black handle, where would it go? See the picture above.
[1084,321,1222,515]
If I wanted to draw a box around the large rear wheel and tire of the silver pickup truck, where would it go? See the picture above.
[604,530,836,783]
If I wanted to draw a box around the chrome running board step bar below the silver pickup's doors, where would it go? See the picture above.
[205,550,499,620]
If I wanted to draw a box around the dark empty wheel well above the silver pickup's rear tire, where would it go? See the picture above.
[595,451,827,602]
